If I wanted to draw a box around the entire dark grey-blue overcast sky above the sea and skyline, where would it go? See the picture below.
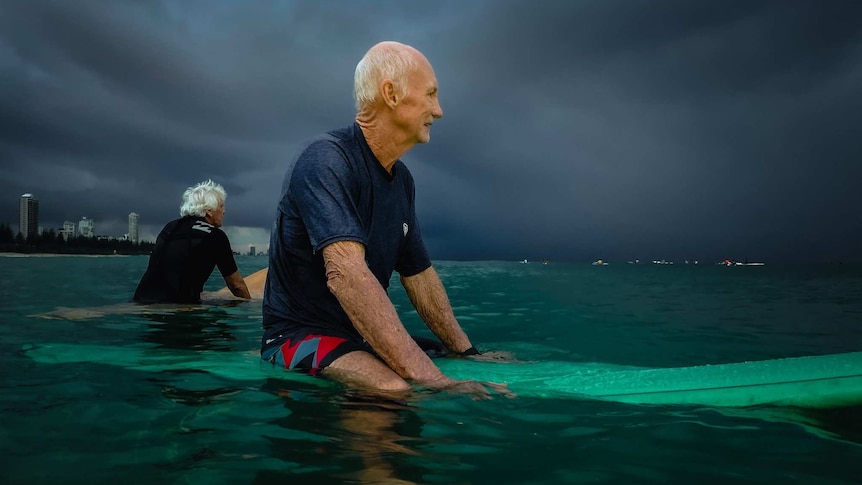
[0,0,862,262]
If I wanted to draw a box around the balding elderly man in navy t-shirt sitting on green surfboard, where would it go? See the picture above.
[261,42,505,393]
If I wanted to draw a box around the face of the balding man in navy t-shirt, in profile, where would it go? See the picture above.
[397,59,443,143]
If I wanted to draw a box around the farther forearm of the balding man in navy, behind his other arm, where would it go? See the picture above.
[401,266,473,353]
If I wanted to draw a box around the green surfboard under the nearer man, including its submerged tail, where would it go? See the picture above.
[22,343,862,408]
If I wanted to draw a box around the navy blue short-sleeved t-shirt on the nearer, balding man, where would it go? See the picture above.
[263,123,431,348]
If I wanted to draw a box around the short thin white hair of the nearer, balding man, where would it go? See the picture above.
[353,42,418,111]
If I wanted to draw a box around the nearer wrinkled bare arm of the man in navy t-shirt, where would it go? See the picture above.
[323,241,454,387]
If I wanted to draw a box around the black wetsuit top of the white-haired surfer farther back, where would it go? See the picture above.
[134,216,237,303]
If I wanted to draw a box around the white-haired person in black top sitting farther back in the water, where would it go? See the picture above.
[133,180,250,303]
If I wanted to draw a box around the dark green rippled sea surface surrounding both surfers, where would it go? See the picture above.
[0,256,862,485]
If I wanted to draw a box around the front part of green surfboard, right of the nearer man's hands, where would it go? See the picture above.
[440,352,862,408]
